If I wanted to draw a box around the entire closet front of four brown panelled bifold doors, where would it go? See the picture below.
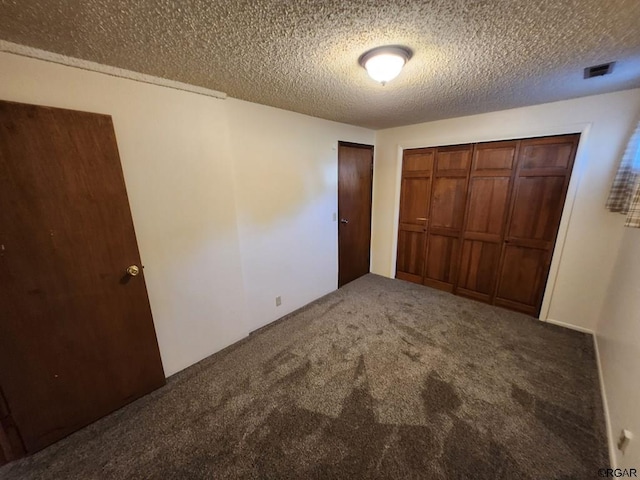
[396,134,580,316]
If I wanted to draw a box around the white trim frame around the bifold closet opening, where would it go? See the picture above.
[386,123,592,320]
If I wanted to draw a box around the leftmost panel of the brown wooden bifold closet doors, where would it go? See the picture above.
[396,148,435,283]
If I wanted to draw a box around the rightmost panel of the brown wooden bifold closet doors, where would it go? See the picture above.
[494,135,579,316]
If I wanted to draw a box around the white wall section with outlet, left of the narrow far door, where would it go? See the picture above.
[227,99,374,330]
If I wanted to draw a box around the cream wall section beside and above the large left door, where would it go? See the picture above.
[0,53,247,375]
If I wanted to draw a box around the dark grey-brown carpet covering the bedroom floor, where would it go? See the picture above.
[0,275,608,480]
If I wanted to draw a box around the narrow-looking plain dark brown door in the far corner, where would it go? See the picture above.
[338,142,373,287]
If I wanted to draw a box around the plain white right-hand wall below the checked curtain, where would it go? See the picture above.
[596,210,640,468]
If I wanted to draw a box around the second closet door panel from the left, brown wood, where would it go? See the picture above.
[422,145,473,292]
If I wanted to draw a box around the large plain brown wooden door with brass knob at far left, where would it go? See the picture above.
[0,102,165,459]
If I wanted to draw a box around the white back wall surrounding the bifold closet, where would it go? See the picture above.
[372,89,640,331]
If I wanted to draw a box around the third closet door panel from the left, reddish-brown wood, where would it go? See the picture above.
[456,141,519,303]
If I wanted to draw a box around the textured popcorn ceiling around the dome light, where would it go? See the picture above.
[0,0,640,128]
